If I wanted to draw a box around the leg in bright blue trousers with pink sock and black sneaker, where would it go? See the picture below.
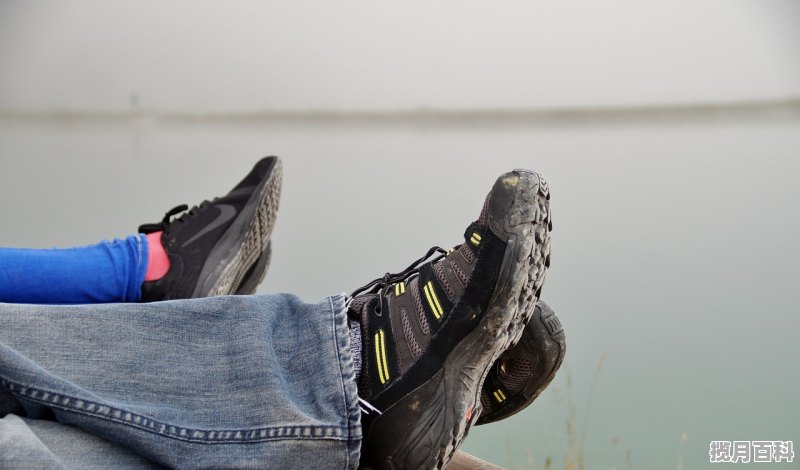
[0,157,281,304]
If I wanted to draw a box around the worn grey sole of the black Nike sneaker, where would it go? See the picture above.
[192,158,283,297]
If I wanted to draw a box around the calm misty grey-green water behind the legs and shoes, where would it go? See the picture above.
[0,112,800,469]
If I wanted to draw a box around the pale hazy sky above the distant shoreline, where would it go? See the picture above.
[0,0,800,112]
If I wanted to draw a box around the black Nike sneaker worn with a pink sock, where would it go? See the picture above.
[139,157,281,302]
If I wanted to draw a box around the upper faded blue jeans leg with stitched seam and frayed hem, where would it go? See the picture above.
[0,294,361,468]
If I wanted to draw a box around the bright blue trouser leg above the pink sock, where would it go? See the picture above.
[0,234,148,304]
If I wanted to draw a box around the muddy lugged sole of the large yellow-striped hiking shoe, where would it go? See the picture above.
[369,170,551,470]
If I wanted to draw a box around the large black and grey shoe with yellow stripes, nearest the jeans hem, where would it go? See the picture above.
[349,170,550,469]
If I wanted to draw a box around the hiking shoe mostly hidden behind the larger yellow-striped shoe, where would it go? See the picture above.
[476,300,567,425]
